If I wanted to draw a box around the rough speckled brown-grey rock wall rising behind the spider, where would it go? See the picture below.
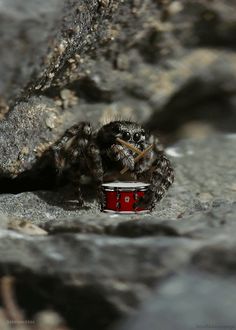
[0,0,236,177]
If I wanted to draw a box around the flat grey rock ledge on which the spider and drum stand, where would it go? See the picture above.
[0,134,236,227]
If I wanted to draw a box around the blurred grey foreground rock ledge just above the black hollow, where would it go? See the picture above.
[0,230,199,314]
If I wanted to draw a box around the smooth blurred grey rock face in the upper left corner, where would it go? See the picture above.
[0,0,63,100]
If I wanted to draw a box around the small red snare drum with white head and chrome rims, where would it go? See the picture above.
[102,182,150,213]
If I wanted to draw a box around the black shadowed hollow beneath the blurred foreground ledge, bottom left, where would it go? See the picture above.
[9,270,121,330]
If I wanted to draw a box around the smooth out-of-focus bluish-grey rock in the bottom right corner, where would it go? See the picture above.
[116,272,236,330]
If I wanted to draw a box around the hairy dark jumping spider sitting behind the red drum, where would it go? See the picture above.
[53,120,174,209]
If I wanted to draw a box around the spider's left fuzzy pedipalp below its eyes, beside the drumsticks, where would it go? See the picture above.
[110,144,135,171]
